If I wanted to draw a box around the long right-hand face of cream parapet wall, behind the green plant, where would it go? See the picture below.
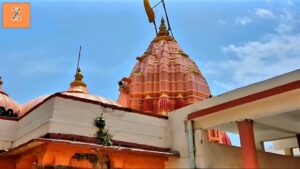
[50,97,170,148]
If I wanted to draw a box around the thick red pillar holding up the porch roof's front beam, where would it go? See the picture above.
[237,119,258,169]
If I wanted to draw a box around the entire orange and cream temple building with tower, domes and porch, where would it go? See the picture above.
[0,1,300,169]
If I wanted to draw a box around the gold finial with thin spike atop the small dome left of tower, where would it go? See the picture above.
[68,46,88,93]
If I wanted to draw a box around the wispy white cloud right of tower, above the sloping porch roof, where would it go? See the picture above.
[206,6,300,91]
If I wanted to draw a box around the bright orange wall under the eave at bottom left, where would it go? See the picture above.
[0,143,168,169]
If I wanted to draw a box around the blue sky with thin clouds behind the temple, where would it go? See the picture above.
[0,0,300,103]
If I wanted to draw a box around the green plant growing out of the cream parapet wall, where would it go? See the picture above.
[95,113,112,146]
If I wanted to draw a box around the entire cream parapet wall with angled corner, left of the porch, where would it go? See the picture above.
[0,97,171,149]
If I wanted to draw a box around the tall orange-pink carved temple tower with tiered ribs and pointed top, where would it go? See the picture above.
[118,19,210,115]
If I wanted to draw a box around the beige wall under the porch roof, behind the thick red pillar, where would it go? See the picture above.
[195,129,300,168]
